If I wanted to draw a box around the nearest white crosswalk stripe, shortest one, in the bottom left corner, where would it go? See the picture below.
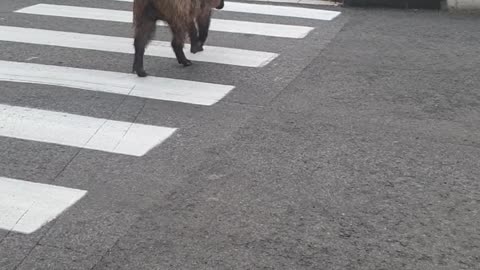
[0,177,87,234]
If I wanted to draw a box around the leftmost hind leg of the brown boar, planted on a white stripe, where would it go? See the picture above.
[132,7,156,77]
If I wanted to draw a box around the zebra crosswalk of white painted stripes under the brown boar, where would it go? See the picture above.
[0,0,340,234]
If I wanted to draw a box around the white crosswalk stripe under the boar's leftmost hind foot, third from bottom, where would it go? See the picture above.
[0,60,235,105]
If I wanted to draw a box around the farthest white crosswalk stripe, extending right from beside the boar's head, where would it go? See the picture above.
[116,0,341,21]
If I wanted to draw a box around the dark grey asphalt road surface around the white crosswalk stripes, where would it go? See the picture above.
[0,0,480,270]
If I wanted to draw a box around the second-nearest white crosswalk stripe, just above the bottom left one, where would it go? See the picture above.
[0,105,176,156]
